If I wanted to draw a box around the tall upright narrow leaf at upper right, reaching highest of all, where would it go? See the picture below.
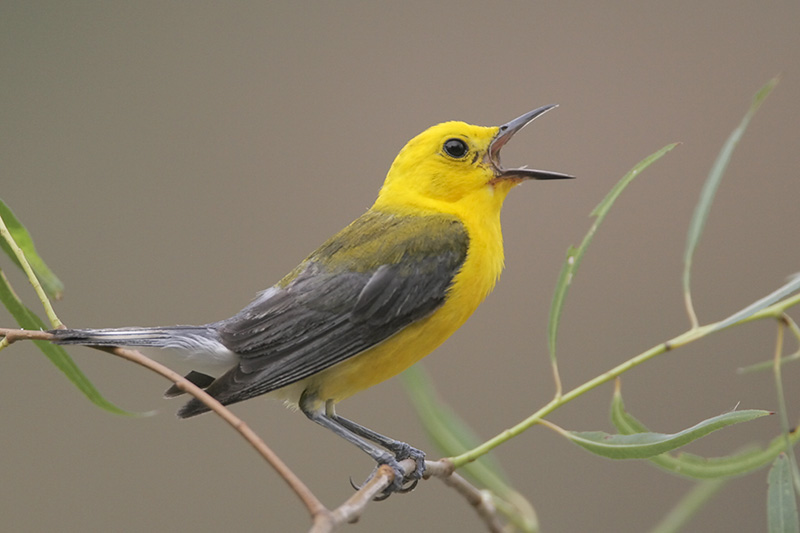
[683,78,778,314]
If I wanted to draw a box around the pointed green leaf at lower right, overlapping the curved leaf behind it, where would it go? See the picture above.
[566,409,770,459]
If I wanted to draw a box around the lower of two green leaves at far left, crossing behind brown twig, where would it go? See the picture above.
[0,270,142,416]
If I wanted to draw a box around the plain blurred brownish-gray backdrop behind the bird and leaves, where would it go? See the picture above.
[0,4,800,533]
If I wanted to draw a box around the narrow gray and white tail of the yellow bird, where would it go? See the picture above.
[49,325,219,348]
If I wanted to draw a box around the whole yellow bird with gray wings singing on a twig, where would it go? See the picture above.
[52,105,572,495]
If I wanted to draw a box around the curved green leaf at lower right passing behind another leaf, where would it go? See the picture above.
[611,391,800,479]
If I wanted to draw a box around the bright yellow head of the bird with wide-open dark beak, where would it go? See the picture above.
[376,105,572,215]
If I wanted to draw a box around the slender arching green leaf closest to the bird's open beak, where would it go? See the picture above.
[547,143,678,363]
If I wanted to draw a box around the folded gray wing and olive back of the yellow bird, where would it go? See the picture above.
[178,211,469,417]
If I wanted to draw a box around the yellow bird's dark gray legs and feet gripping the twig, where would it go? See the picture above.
[299,394,425,499]
